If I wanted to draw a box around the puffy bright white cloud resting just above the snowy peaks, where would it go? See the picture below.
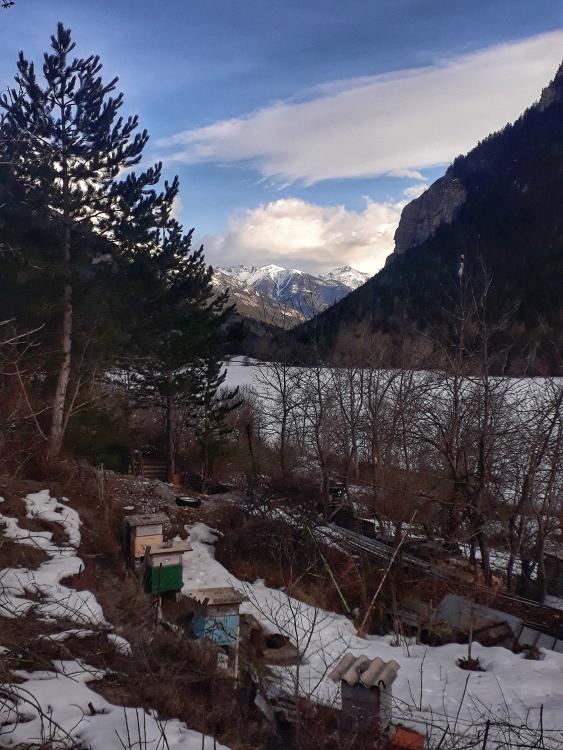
[204,198,406,273]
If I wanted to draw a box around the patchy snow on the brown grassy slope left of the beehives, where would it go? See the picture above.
[0,490,228,750]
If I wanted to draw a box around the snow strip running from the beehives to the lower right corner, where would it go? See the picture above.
[184,524,563,748]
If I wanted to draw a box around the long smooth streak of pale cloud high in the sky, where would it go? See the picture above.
[158,30,563,184]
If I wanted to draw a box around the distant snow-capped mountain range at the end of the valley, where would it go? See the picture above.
[213,264,369,325]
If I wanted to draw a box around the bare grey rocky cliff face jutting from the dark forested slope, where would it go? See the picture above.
[394,173,467,255]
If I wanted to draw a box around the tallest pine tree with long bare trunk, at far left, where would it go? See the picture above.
[0,23,172,460]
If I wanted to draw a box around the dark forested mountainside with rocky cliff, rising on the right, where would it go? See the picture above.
[294,61,563,373]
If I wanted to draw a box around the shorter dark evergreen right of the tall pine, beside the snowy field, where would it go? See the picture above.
[129,206,233,478]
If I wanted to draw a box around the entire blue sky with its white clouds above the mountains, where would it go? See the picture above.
[0,0,563,271]
